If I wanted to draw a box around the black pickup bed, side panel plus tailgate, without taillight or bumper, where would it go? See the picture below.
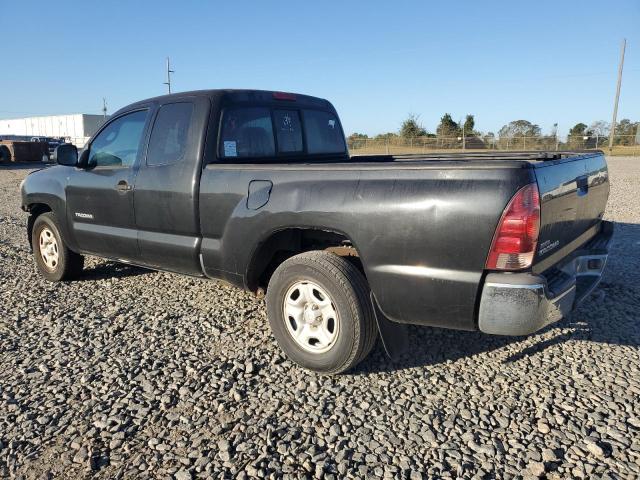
[199,152,609,329]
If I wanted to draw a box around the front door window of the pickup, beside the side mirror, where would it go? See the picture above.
[89,110,147,167]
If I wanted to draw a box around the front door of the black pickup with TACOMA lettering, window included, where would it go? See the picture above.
[66,109,150,262]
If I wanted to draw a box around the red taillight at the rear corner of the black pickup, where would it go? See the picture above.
[486,183,540,270]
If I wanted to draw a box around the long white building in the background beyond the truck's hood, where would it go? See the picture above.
[0,113,104,148]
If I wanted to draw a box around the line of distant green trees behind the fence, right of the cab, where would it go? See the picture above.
[348,113,640,145]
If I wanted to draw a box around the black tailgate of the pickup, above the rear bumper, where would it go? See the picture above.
[533,152,609,272]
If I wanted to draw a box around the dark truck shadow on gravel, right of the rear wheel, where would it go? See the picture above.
[352,222,640,375]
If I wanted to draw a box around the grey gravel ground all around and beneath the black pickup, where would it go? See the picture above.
[0,158,640,479]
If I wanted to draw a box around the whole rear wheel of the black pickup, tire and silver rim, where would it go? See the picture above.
[267,251,378,374]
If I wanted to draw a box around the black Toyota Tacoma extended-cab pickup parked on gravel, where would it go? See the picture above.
[21,90,613,373]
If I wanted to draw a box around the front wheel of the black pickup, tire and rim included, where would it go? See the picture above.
[31,212,84,282]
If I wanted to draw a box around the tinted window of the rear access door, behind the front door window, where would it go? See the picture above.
[147,102,193,165]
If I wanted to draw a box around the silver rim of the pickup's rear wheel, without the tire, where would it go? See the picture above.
[283,281,340,353]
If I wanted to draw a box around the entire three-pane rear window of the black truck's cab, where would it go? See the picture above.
[218,106,346,161]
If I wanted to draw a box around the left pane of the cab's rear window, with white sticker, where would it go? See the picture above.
[218,108,276,158]
